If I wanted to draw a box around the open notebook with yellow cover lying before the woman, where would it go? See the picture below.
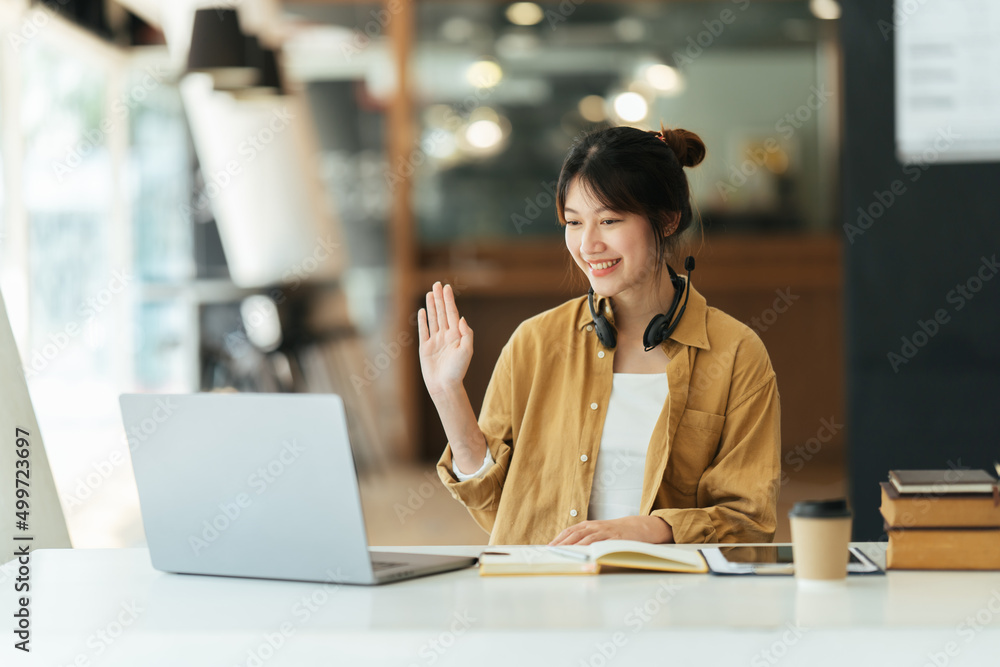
[479,540,708,576]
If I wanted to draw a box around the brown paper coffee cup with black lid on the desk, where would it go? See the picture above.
[788,498,852,583]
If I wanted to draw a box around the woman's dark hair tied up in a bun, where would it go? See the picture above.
[556,127,705,274]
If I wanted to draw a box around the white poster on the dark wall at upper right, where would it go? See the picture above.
[896,0,1000,164]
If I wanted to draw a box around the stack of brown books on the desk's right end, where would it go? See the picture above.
[880,470,1000,570]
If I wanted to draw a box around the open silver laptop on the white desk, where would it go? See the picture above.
[121,394,476,584]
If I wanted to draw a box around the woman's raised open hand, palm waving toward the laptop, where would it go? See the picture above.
[417,282,472,398]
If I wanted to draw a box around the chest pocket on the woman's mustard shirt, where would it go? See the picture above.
[665,409,726,496]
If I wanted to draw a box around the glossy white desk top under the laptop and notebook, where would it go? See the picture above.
[0,544,1000,667]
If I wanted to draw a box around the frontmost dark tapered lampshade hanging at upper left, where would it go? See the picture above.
[186,7,260,90]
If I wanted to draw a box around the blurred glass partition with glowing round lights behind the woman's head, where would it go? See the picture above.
[413,1,839,244]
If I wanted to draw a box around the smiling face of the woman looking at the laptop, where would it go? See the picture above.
[563,178,657,297]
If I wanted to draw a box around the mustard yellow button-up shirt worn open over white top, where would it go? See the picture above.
[437,288,781,544]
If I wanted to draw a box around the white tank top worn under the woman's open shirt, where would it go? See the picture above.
[587,373,669,519]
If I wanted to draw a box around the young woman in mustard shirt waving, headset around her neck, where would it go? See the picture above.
[417,127,781,544]
